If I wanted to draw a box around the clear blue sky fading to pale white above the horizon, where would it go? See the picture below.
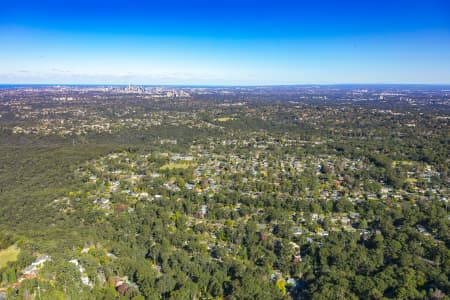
[0,0,450,84]
